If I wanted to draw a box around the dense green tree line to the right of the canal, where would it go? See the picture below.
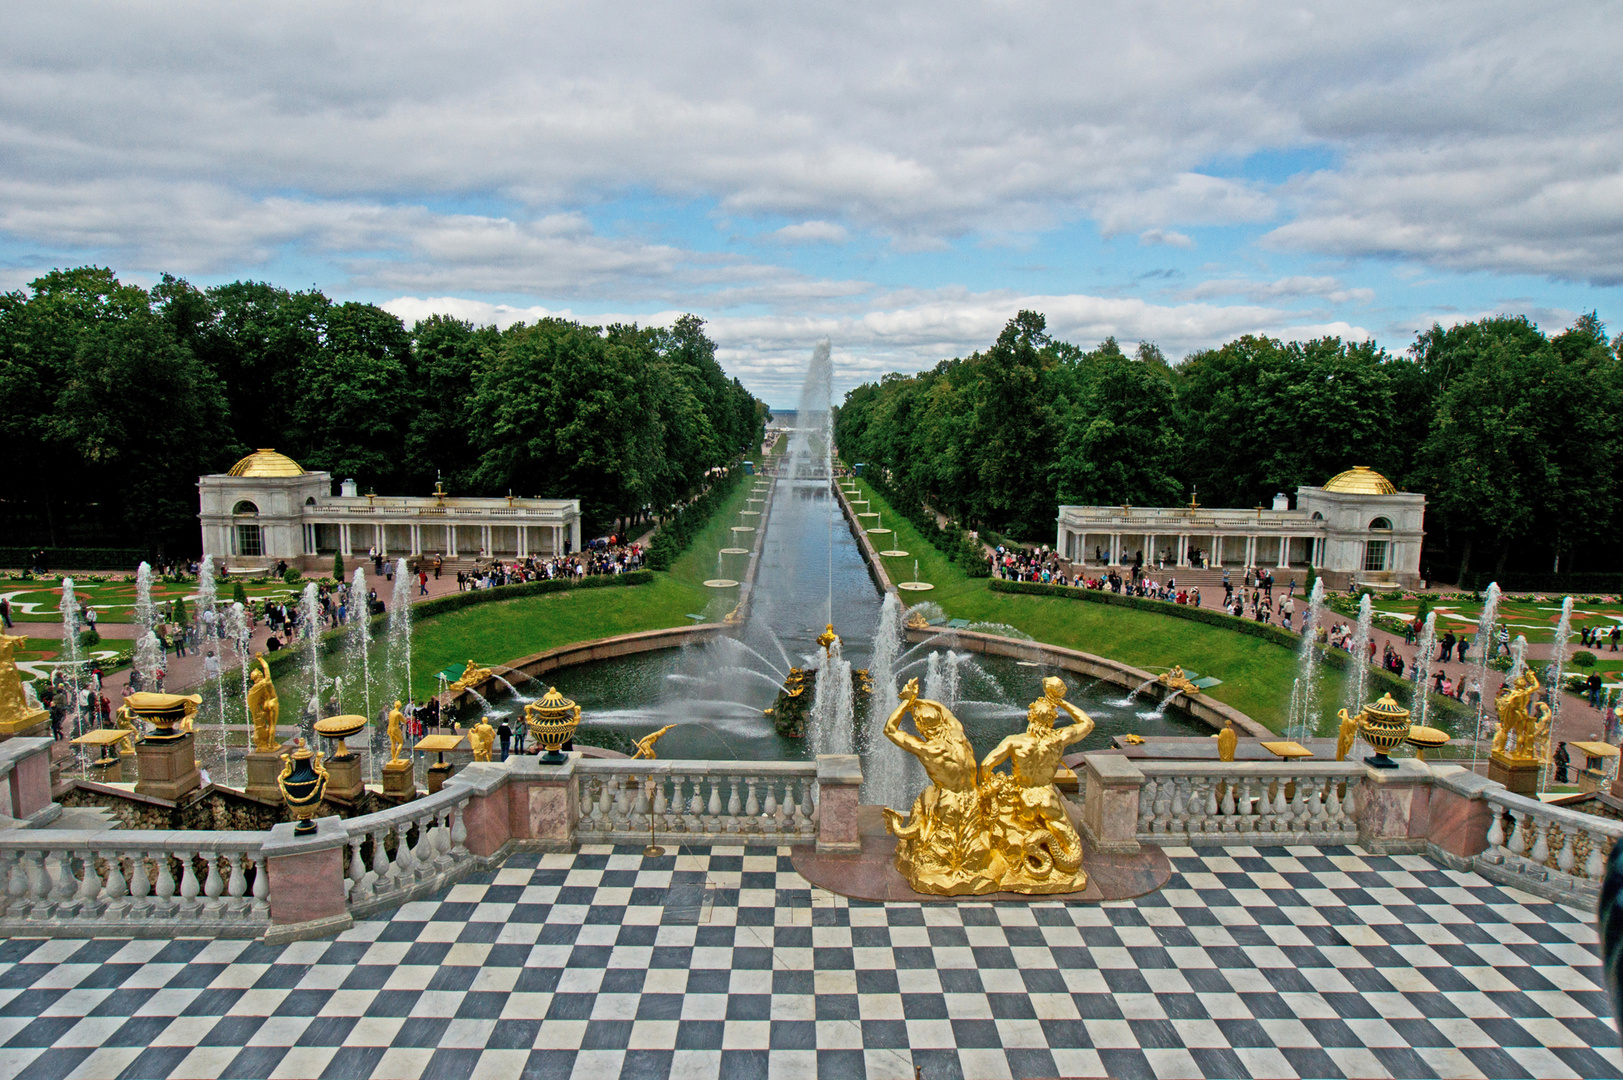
[836,312,1623,580]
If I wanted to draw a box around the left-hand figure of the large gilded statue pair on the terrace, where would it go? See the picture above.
[885,679,1003,896]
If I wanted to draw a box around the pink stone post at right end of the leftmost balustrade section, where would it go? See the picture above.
[260,817,354,945]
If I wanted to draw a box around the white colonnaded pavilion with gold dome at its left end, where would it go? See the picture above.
[198,450,581,570]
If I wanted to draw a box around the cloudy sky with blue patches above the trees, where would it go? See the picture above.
[0,0,1623,408]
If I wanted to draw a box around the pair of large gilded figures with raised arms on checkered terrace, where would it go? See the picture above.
[885,677,1094,896]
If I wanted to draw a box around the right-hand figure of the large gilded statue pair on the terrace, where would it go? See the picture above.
[980,676,1094,893]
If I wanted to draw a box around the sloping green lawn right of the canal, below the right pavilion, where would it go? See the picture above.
[847,479,1342,729]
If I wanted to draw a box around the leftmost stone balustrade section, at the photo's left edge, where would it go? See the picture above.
[0,827,269,937]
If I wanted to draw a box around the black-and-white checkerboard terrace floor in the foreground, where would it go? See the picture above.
[0,848,1623,1080]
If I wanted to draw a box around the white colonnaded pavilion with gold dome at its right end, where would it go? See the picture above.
[1055,464,1425,588]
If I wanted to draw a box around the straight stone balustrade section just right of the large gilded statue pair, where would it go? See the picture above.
[1136,762,1365,845]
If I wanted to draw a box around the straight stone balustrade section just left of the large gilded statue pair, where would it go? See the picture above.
[575,758,818,846]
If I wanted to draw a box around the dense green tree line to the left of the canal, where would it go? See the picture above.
[0,266,766,554]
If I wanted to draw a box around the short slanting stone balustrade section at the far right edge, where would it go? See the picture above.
[1474,788,1623,908]
